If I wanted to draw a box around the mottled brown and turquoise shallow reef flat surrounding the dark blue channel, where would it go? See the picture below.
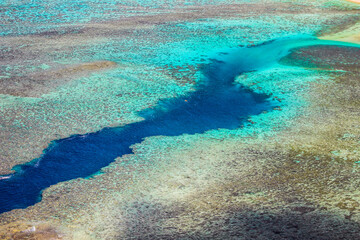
[0,1,360,239]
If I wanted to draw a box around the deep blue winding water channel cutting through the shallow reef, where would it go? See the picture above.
[0,37,338,213]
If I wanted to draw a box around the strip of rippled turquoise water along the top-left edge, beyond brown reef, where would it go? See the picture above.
[0,0,256,36]
